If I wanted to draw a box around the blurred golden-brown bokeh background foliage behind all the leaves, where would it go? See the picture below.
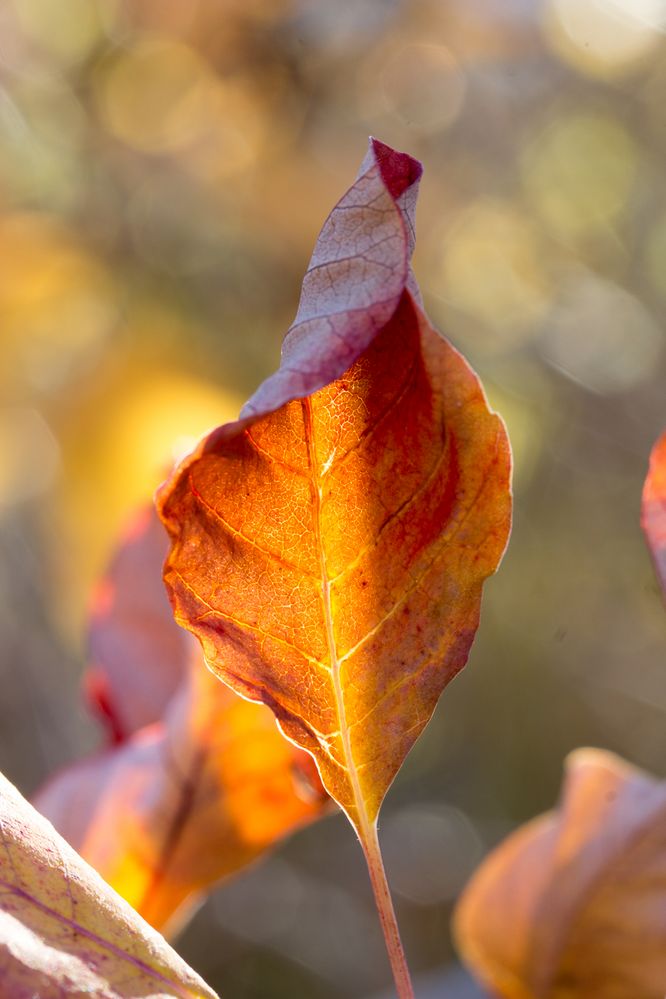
[0,0,666,999]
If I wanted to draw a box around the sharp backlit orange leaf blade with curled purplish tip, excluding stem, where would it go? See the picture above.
[158,140,510,842]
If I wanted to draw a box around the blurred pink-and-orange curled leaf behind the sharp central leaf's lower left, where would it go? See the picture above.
[35,514,327,932]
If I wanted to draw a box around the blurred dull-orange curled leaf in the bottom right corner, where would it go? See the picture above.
[454,749,666,999]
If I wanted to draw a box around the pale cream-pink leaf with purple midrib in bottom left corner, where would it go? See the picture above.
[0,775,215,999]
